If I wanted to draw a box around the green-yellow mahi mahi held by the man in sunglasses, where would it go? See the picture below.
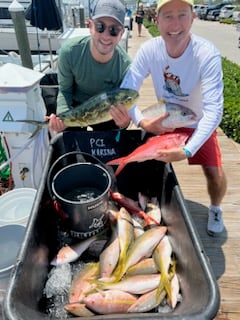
[16,88,139,137]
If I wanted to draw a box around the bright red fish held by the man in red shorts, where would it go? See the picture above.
[107,132,189,176]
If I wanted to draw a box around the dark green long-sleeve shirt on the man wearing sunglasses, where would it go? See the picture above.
[57,36,131,114]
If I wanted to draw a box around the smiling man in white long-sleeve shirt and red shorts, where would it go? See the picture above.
[111,0,227,236]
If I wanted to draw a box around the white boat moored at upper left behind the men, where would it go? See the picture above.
[0,0,130,54]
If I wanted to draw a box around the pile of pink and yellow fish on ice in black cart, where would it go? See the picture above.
[45,192,181,317]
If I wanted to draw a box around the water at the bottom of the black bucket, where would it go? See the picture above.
[63,187,102,203]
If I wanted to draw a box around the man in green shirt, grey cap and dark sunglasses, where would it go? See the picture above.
[49,0,131,132]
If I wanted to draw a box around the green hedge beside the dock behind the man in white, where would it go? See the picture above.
[144,21,240,143]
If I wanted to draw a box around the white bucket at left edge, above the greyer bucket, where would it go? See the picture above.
[0,188,37,226]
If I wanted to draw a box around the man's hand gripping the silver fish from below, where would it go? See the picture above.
[140,113,175,135]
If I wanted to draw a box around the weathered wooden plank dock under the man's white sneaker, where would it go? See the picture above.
[128,23,240,320]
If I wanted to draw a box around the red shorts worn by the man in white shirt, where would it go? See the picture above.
[175,128,222,167]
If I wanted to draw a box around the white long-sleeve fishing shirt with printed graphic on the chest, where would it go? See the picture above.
[121,35,223,155]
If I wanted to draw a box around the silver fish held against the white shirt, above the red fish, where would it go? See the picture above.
[142,100,197,128]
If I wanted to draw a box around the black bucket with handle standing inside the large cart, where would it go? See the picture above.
[48,154,112,239]
